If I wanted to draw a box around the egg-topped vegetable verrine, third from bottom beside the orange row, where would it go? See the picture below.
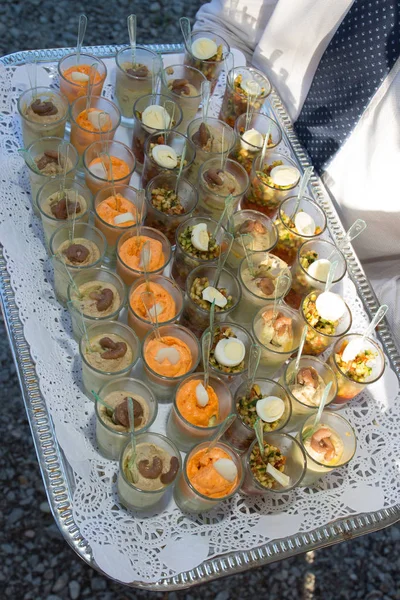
[202,323,253,394]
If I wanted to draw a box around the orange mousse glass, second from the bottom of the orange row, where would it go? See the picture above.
[167,373,233,452]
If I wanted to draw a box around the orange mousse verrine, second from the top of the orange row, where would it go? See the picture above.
[71,96,121,157]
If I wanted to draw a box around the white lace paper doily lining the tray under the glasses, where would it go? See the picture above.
[0,56,400,582]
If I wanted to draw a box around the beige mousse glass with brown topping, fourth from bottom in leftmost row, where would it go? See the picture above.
[67,267,126,340]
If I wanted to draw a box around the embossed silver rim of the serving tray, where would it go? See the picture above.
[0,44,400,591]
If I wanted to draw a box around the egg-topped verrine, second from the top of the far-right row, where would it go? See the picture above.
[230,112,282,175]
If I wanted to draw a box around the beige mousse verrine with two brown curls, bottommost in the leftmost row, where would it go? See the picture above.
[117,431,182,511]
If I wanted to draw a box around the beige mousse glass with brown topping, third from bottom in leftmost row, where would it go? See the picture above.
[79,321,140,398]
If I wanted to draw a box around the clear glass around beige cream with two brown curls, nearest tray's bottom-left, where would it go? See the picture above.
[117,432,182,511]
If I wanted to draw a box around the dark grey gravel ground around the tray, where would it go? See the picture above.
[0,0,400,600]
